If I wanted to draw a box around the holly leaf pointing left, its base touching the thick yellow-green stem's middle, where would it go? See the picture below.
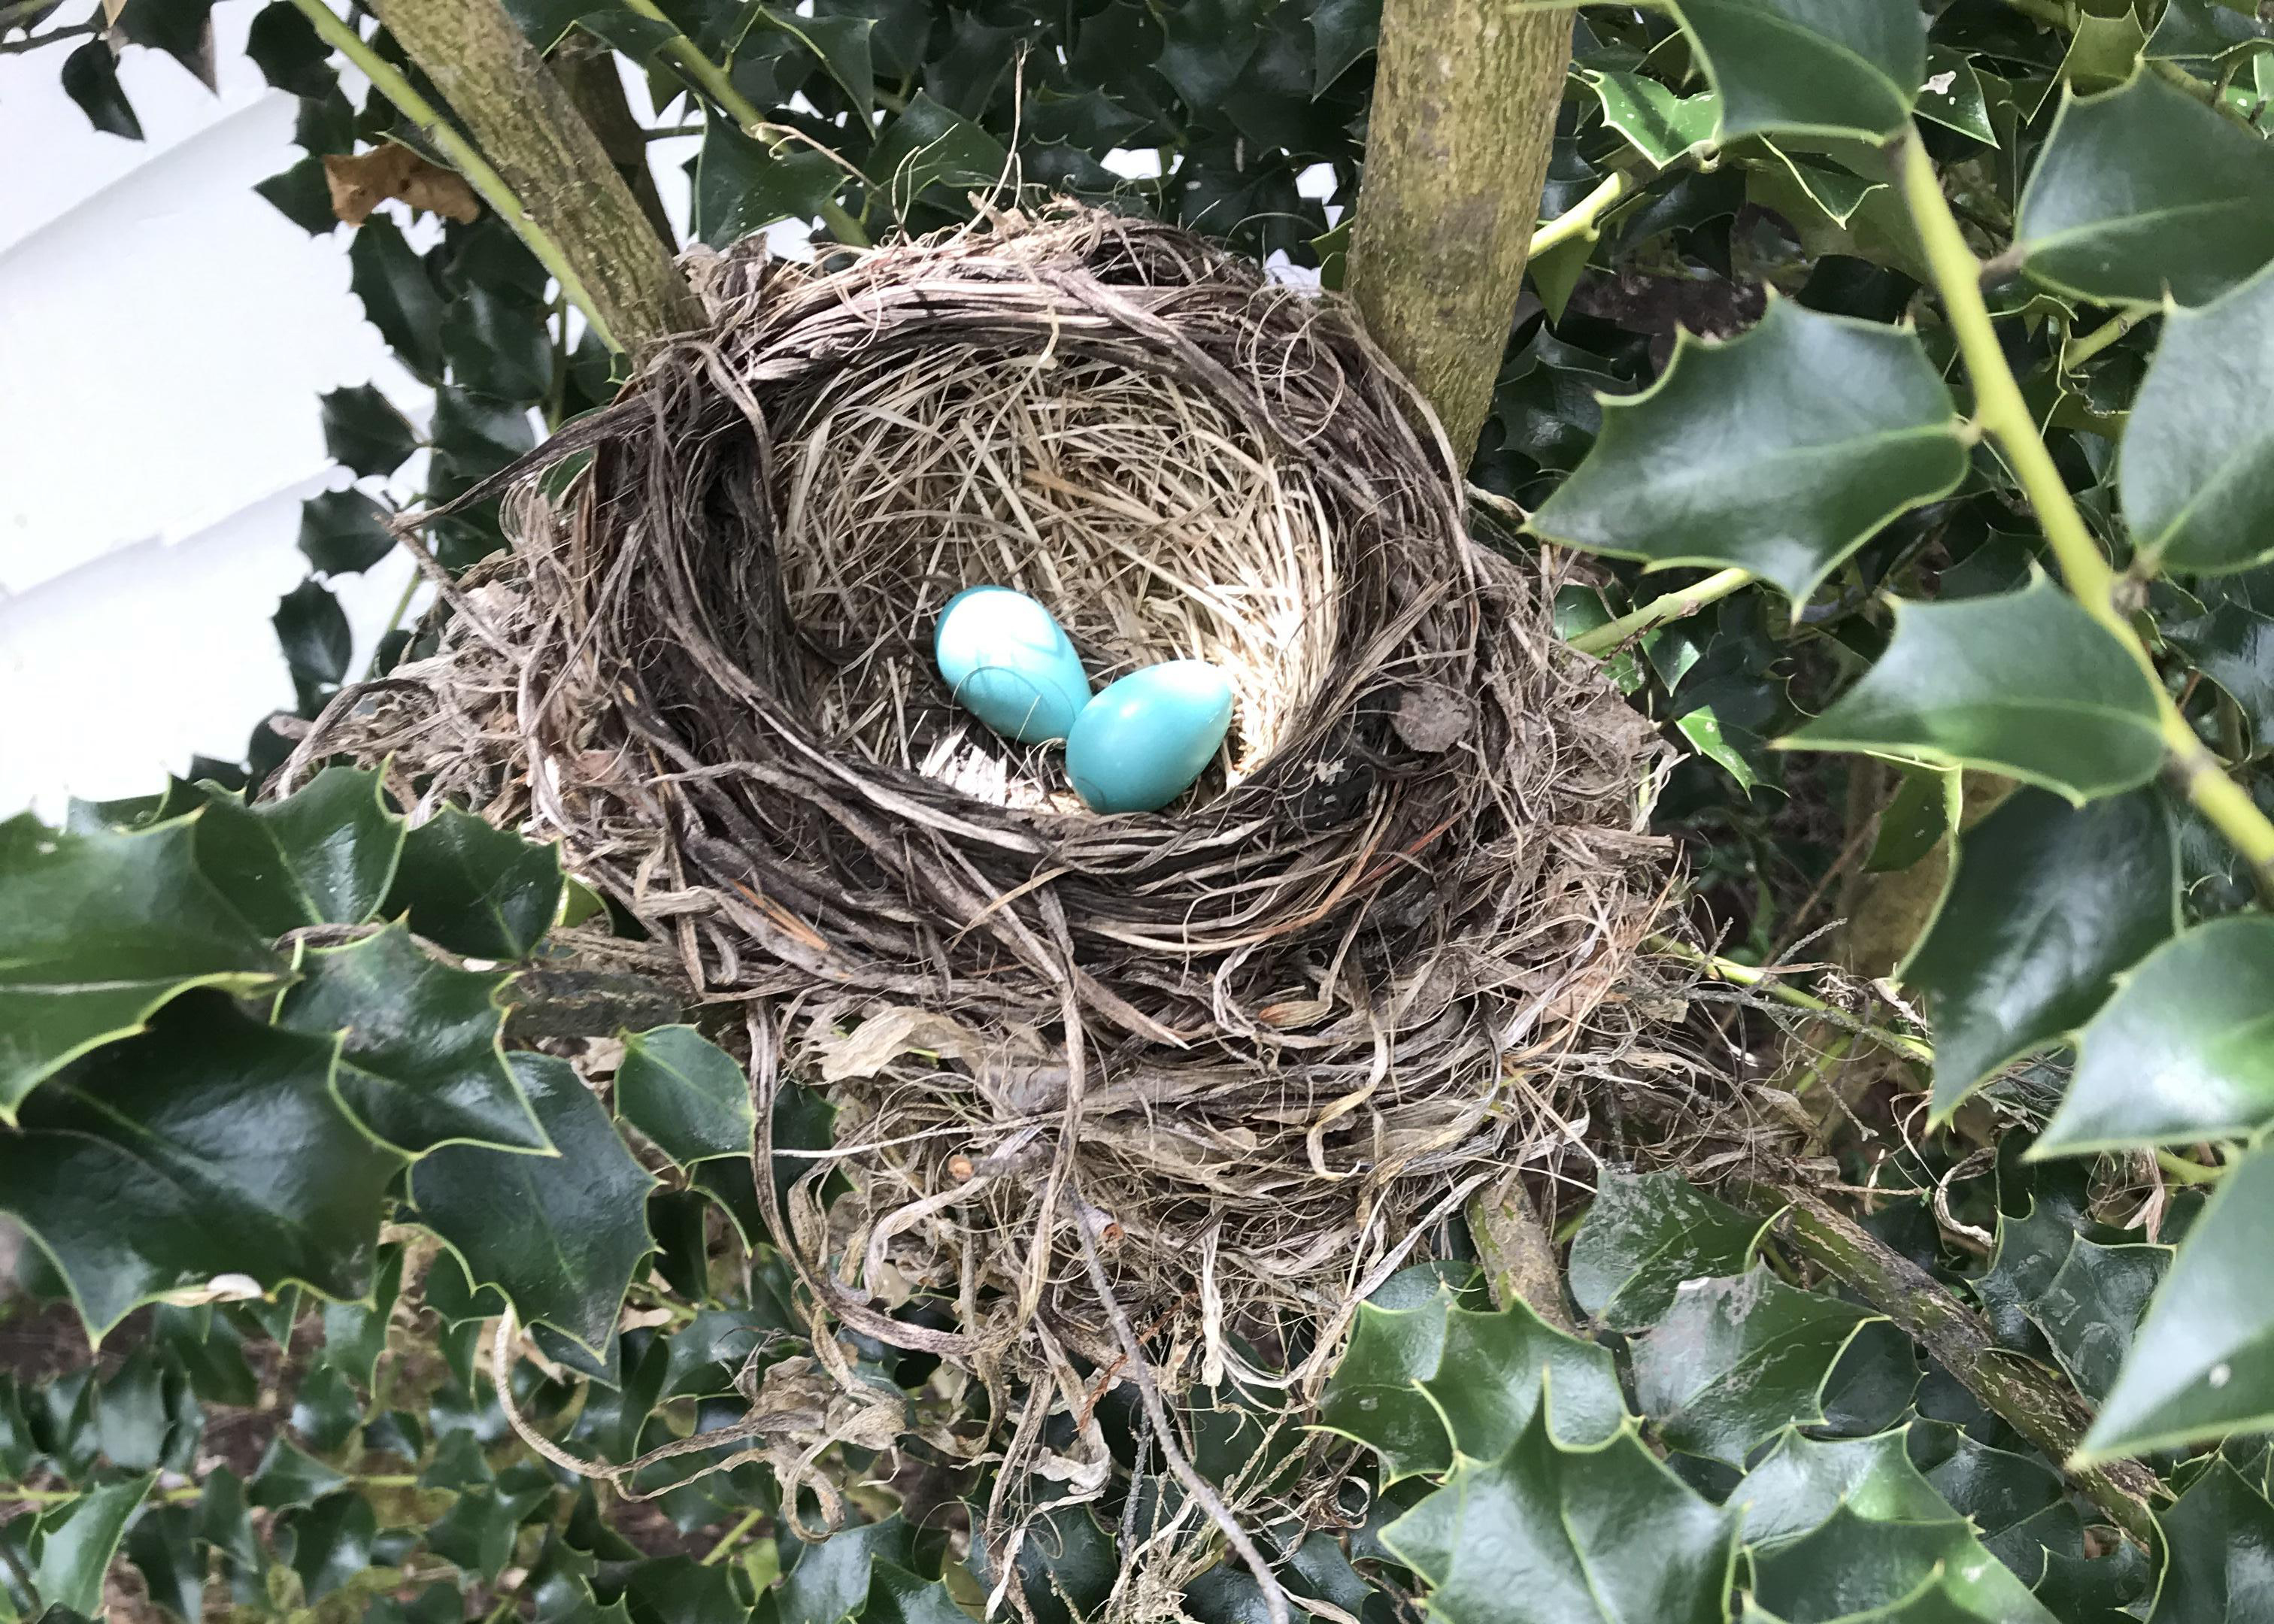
[1785,577,2163,801]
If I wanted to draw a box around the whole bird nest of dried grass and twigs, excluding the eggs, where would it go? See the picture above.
[289,209,1667,1592]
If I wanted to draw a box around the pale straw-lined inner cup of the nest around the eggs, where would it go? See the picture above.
[771,332,1339,812]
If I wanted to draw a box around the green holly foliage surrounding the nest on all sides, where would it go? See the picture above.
[0,0,2274,1624]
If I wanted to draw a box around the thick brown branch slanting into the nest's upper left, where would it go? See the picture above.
[373,0,702,350]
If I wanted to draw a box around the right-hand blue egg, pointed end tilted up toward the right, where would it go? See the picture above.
[1066,659,1233,812]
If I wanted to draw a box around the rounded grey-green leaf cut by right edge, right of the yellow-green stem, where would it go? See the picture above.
[2117,256,2274,571]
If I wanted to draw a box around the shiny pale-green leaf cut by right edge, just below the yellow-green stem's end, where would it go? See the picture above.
[2033,914,2274,1156]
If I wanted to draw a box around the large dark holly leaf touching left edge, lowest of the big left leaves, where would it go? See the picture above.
[0,994,402,1338]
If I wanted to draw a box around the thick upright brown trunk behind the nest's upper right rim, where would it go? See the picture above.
[1348,0,1572,464]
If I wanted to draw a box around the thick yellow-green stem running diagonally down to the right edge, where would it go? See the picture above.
[1899,129,2274,898]
